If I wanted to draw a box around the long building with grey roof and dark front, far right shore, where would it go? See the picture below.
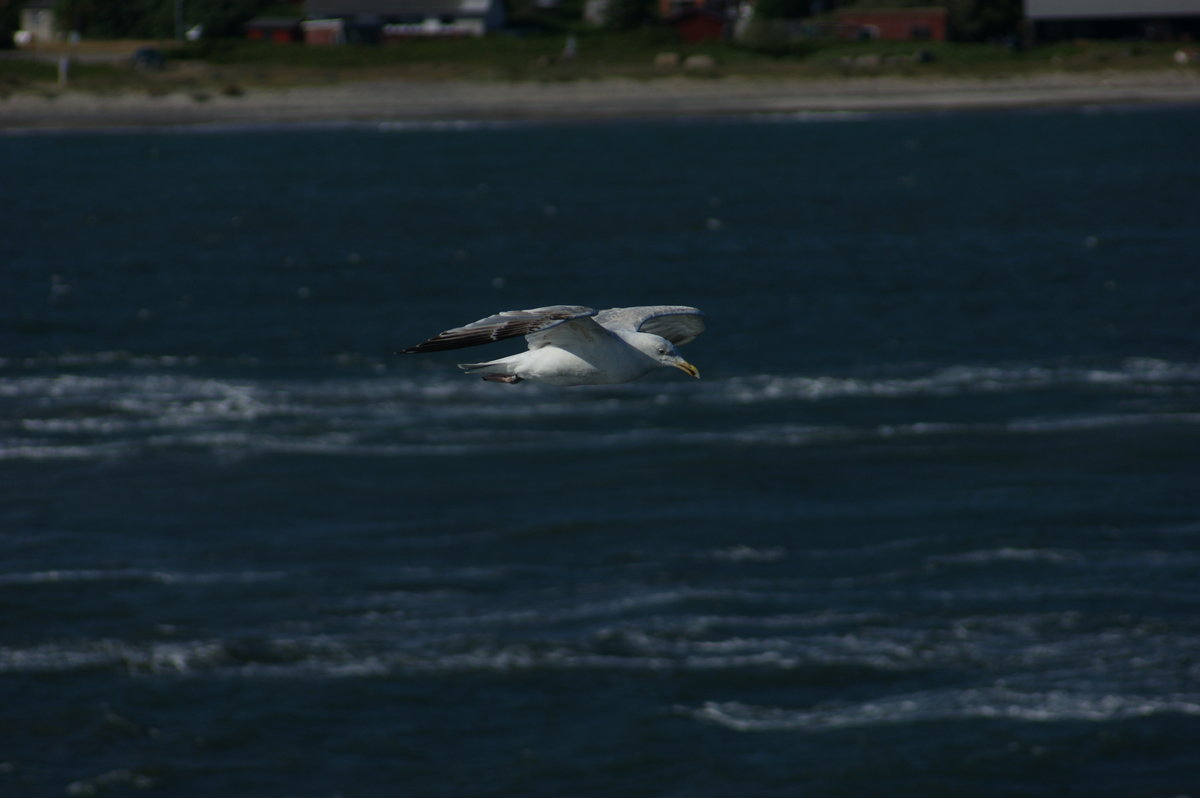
[1025,0,1200,42]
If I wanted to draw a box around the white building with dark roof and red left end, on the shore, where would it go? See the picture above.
[305,0,505,38]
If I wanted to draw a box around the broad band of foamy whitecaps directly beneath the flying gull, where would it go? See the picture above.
[0,353,1200,461]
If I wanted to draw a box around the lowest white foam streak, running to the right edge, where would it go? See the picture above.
[678,686,1200,732]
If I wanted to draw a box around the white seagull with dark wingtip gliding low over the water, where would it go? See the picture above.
[400,305,704,386]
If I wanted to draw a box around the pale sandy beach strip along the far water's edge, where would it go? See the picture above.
[0,70,1200,132]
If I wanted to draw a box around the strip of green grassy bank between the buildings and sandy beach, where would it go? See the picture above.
[0,30,1196,96]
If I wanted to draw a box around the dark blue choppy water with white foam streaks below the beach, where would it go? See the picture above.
[0,109,1200,798]
